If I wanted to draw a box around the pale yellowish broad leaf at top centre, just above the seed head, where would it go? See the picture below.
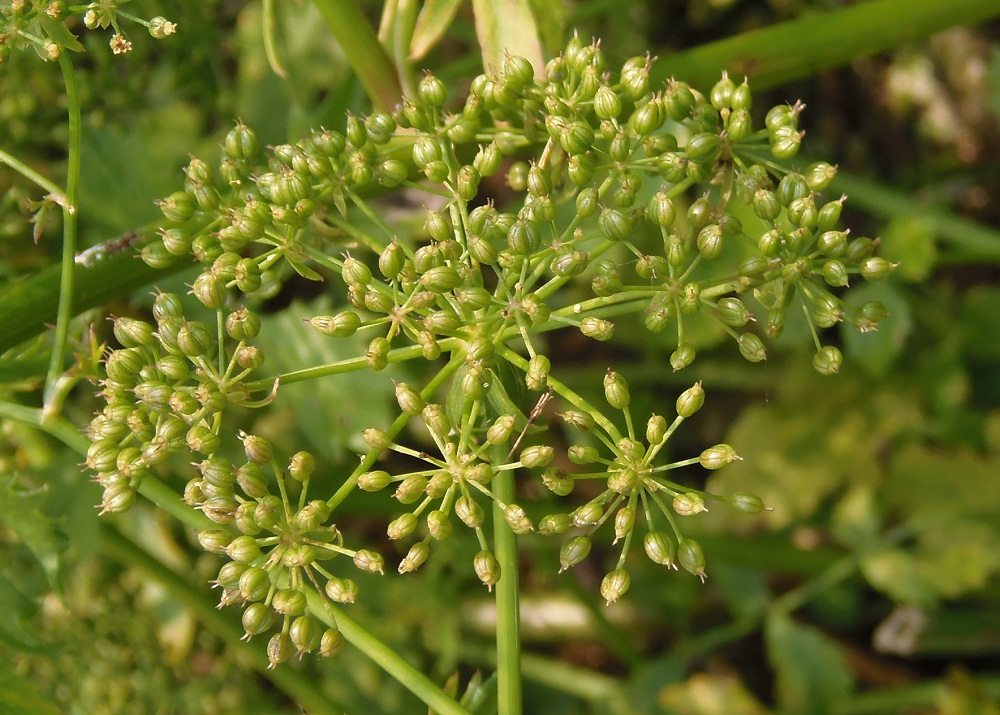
[472,0,545,76]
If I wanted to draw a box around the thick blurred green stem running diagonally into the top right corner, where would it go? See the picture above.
[652,0,1000,89]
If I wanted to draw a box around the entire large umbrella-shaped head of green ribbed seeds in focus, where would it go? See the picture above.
[80,32,893,663]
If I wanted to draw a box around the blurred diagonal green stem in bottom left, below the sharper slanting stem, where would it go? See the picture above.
[100,523,346,715]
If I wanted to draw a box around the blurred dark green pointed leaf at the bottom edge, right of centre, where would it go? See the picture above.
[764,612,852,715]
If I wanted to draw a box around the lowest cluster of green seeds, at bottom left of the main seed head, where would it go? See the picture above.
[193,440,374,667]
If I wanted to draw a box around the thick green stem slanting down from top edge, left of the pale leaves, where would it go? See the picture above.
[313,0,403,111]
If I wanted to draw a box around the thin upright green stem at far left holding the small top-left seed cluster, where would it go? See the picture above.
[45,52,82,412]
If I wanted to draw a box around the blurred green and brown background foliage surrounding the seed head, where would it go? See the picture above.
[0,0,1000,715]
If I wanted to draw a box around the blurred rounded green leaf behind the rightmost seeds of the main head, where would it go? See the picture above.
[841,283,913,377]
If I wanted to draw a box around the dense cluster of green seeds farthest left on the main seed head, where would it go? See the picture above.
[85,293,276,513]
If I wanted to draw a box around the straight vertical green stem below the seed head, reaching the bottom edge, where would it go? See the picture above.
[492,453,521,715]
